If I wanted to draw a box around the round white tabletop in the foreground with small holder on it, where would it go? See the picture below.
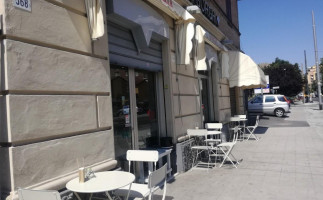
[66,171,135,193]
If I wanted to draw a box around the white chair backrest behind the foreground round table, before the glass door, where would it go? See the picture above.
[127,150,159,171]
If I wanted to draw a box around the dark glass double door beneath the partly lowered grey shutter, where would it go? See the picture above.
[111,65,159,167]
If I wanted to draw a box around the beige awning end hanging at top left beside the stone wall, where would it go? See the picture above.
[85,0,104,40]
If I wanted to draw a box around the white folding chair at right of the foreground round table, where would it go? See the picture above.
[115,163,167,200]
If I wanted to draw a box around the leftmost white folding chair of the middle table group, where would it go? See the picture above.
[187,129,210,168]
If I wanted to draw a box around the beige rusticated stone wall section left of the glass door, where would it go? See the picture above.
[0,0,115,199]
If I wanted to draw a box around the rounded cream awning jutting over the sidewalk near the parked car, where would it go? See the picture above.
[228,51,267,89]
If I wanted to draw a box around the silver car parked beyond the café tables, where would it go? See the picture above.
[248,94,289,117]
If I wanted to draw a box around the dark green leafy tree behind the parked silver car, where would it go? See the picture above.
[264,58,304,96]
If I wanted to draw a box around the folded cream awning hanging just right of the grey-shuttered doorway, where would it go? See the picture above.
[176,10,195,65]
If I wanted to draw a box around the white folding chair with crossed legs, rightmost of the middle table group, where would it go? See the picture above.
[217,126,239,168]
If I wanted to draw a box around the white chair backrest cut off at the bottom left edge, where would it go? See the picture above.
[18,189,61,200]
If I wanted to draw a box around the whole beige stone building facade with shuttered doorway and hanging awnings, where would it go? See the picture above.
[0,0,248,199]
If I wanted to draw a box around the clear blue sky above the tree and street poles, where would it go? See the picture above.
[238,0,323,70]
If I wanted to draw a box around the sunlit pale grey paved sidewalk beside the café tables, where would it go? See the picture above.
[154,102,323,200]
